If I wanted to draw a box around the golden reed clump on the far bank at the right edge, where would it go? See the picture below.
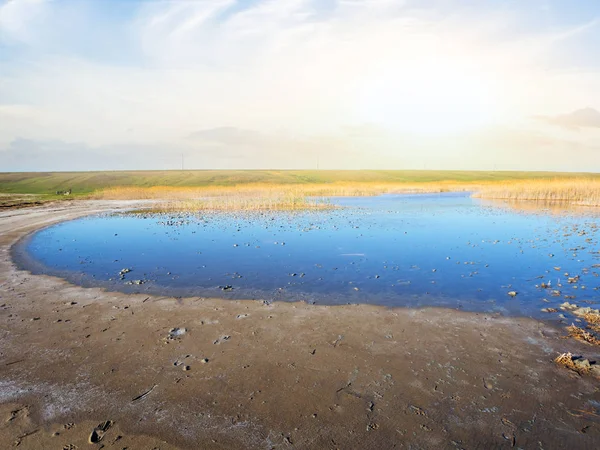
[475,178,600,206]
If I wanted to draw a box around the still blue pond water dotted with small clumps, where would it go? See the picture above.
[18,193,600,316]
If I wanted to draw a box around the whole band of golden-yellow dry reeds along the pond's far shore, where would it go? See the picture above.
[90,178,600,210]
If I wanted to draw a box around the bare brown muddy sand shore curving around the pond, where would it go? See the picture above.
[0,202,600,450]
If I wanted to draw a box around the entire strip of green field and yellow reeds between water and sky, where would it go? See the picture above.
[0,170,600,210]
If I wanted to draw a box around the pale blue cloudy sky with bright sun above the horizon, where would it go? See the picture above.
[0,0,600,172]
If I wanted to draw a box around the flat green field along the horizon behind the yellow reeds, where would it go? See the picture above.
[0,170,600,196]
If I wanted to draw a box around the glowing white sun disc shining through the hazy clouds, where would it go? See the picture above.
[359,55,502,134]
